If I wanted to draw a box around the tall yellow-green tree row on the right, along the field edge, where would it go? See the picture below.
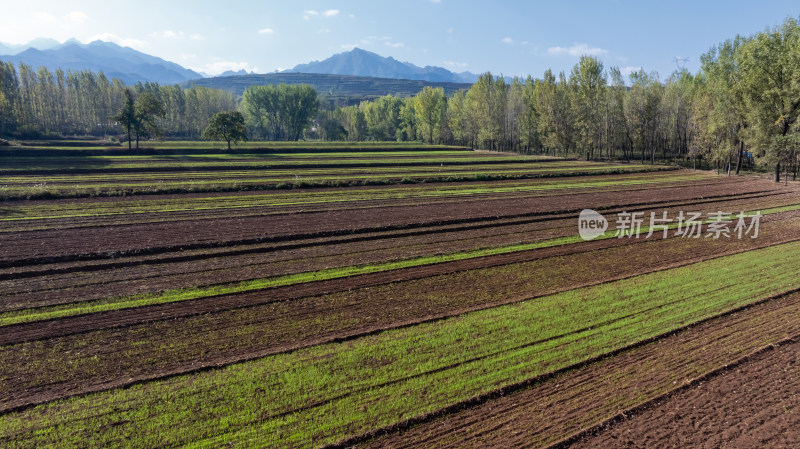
[310,18,800,180]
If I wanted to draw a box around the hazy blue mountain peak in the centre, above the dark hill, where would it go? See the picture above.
[284,47,478,83]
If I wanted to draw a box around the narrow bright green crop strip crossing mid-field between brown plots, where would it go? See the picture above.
[0,200,788,327]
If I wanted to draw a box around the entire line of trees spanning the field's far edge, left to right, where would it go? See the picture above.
[0,18,800,179]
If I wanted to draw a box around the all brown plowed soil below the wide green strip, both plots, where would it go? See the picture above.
[359,294,800,448]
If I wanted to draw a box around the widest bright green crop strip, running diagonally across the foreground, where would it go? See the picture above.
[0,243,800,448]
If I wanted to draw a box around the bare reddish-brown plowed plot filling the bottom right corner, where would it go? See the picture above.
[570,340,800,449]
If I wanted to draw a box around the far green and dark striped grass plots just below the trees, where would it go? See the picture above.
[0,142,675,200]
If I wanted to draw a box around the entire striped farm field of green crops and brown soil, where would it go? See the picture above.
[0,143,800,448]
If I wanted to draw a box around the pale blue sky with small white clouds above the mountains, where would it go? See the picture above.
[0,0,800,78]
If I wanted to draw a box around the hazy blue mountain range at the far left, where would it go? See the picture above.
[0,39,203,85]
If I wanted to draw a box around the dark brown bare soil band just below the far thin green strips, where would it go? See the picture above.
[0,174,771,266]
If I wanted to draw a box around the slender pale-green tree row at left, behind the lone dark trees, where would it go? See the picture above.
[0,61,238,139]
